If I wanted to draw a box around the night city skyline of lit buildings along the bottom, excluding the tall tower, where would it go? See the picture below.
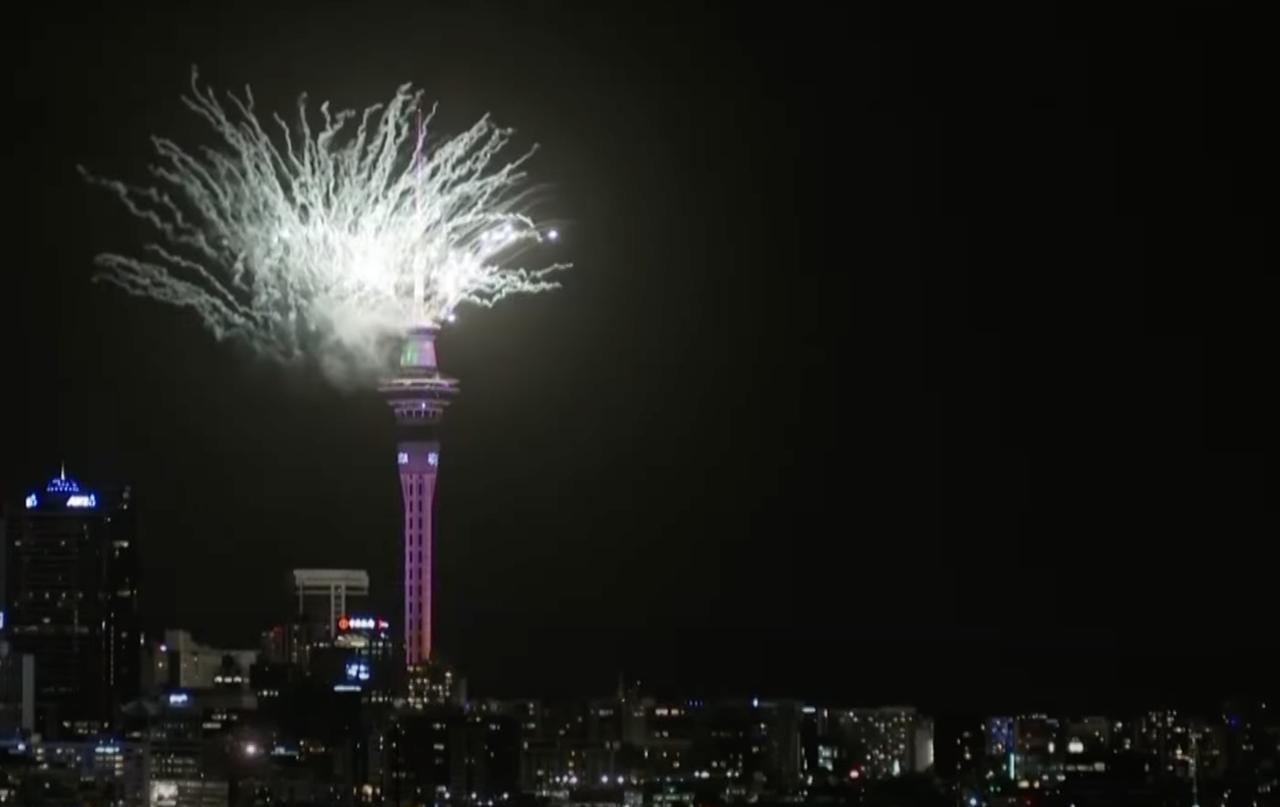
[0,473,1280,807]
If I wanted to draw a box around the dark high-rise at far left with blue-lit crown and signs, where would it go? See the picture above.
[5,470,141,737]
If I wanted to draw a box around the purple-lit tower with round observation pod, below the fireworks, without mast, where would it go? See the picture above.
[379,328,458,665]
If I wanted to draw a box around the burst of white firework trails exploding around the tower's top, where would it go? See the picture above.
[81,70,567,376]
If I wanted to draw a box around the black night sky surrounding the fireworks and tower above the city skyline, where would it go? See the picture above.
[0,1,1280,703]
